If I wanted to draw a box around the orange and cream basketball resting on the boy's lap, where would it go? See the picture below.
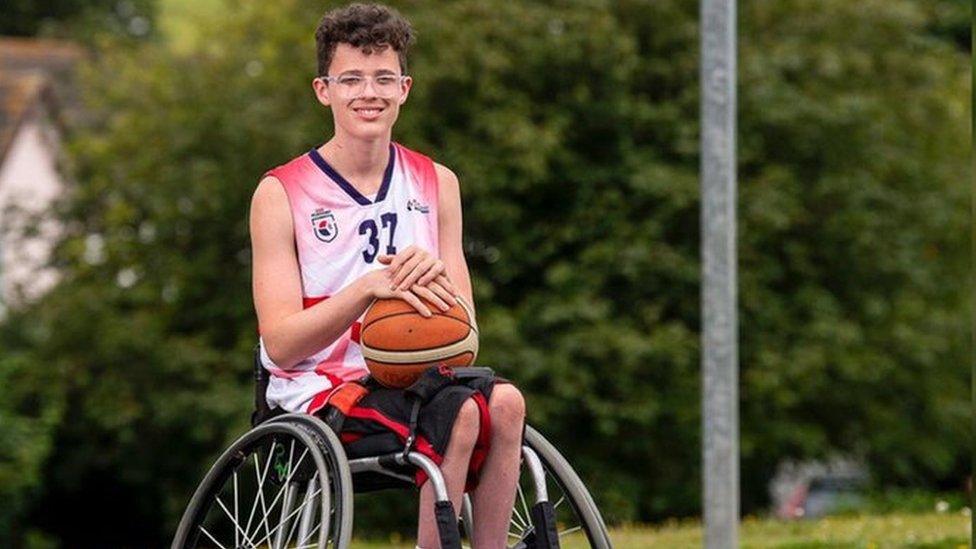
[359,297,478,389]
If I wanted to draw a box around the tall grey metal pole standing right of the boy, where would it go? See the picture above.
[701,0,739,549]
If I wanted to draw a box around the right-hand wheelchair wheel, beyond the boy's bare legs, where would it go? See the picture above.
[461,425,612,549]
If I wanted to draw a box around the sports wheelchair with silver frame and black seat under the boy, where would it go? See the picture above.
[172,356,612,549]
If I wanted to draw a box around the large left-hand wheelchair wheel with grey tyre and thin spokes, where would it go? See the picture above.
[172,416,352,549]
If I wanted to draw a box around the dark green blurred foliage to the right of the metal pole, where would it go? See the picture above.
[740,2,971,501]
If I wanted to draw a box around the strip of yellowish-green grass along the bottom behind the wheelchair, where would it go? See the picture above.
[353,512,970,549]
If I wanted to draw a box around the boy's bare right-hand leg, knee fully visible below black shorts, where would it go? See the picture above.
[471,383,525,549]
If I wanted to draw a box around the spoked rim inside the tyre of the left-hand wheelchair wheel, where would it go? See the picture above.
[187,433,337,549]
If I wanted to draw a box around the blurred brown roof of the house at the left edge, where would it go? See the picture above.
[0,37,85,163]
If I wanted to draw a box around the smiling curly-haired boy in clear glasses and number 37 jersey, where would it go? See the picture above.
[250,4,525,549]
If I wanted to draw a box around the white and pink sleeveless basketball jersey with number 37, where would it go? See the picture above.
[260,143,440,413]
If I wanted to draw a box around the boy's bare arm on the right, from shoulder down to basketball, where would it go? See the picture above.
[434,163,474,310]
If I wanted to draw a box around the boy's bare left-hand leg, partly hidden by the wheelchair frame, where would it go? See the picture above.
[417,399,481,549]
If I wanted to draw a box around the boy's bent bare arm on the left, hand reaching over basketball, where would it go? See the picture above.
[250,177,430,369]
